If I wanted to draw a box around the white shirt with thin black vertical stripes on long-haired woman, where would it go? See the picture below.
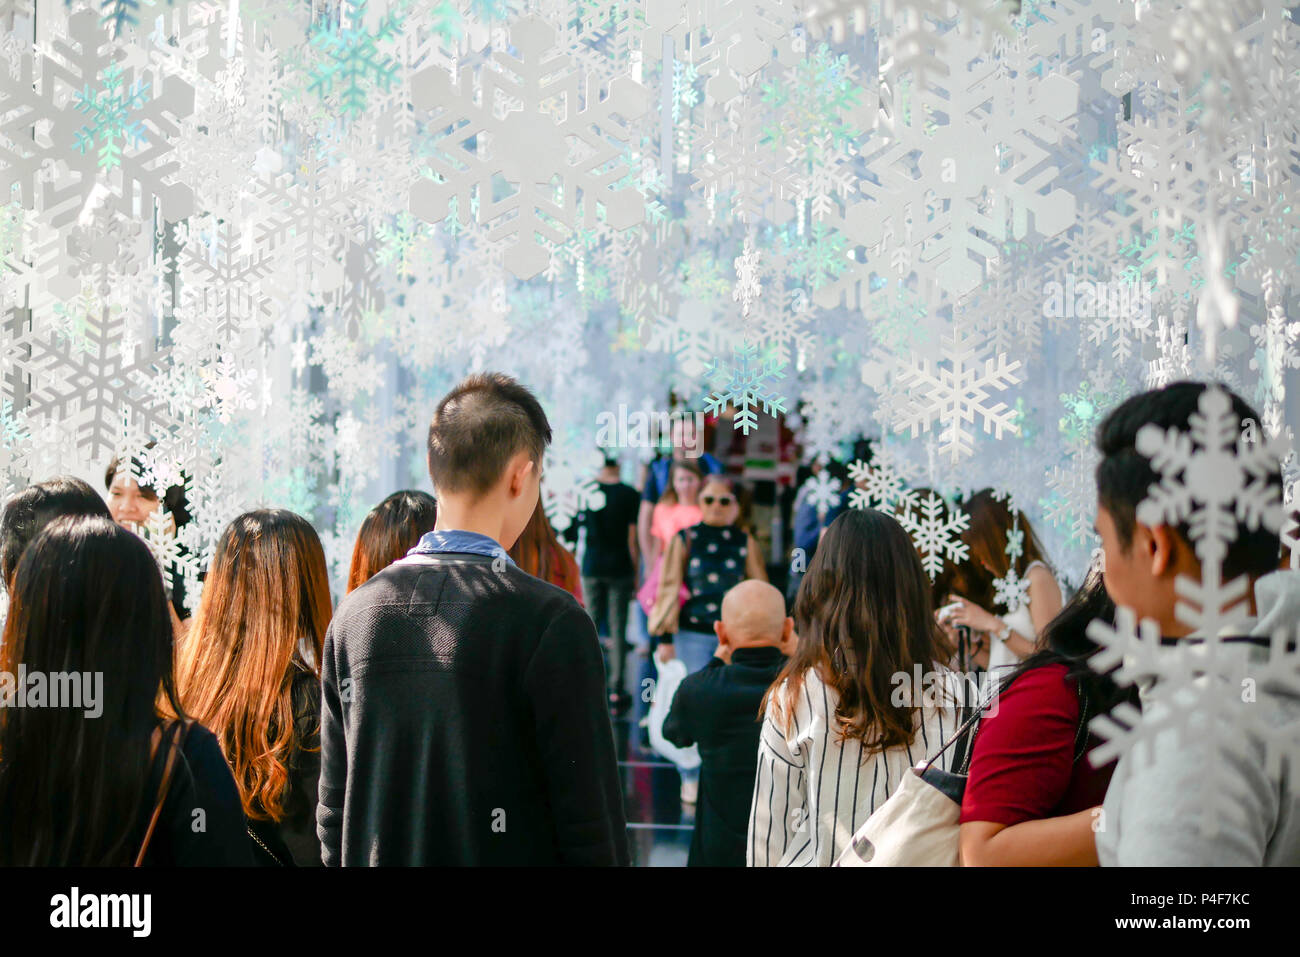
[745,666,959,867]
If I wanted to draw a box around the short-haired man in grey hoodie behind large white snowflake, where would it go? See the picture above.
[1095,382,1300,866]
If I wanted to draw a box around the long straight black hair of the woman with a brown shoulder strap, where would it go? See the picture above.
[0,516,183,866]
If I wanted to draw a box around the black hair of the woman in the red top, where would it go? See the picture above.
[998,568,1138,724]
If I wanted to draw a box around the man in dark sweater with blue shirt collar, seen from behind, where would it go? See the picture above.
[317,373,629,865]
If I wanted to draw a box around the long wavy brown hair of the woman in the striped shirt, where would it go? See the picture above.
[763,508,952,752]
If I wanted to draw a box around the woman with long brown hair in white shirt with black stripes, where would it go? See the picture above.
[746,508,959,867]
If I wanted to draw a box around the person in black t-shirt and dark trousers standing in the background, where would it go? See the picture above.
[571,459,641,711]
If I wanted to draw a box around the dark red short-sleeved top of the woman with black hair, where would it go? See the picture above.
[962,664,1115,827]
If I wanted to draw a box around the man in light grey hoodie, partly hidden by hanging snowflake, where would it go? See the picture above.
[1096,382,1300,866]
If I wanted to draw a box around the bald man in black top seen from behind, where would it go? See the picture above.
[663,580,796,867]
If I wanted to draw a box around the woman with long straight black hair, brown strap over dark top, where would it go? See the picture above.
[0,516,252,866]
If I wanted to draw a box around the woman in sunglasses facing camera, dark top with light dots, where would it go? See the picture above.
[650,475,767,672]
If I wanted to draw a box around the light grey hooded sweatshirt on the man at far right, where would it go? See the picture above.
[1097,571,1300,867]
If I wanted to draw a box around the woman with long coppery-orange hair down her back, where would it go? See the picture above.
[177,508,333,866]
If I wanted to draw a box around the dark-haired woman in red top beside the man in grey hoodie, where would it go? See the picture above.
[961,570,1136,867]
